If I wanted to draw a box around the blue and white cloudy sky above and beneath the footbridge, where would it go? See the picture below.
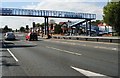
[0,0,109,29]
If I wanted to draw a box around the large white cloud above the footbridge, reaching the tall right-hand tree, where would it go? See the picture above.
[22,0,103,19]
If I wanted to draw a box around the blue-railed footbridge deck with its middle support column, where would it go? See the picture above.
[0,8,96,35]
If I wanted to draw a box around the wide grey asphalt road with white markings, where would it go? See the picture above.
[1,34,118,78]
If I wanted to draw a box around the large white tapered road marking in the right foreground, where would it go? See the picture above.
[70,66,111,78]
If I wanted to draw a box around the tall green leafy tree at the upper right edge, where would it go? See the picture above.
[103,1,120,36]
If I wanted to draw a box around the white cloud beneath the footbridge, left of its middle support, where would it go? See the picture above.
[0,16,44,29]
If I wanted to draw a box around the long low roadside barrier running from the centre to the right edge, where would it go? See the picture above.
[52,36,120,43]
